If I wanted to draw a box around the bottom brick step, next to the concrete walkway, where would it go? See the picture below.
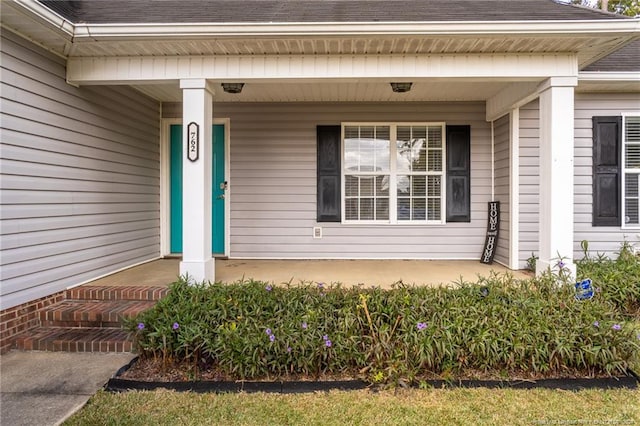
[16,327,133,352]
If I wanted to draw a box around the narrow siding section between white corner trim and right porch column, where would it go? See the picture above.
[518,99,540,269]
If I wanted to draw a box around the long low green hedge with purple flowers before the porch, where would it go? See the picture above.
[128,266,640,383]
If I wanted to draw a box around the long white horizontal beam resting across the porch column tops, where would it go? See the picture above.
[67,54,578,85]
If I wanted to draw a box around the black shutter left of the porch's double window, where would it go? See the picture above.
[317,126,342,222]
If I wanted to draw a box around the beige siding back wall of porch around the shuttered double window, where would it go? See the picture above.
[162,99,491,259]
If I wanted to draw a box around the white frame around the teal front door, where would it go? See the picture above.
[160,118,231,257]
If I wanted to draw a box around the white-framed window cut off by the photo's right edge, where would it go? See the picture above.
[622,115,640,227]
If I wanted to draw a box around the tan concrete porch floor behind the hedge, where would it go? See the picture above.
[82,259,531,288]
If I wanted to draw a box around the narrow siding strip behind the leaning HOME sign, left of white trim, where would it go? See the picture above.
[493,115,511,265]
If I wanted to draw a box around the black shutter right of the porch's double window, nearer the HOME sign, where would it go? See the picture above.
[446,126,471,222]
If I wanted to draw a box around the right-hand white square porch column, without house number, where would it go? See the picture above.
[536,77,577,277]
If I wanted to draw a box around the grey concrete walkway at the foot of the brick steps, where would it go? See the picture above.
[0,351,135,426]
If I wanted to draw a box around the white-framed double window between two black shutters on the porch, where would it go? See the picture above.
[342,123,445,224]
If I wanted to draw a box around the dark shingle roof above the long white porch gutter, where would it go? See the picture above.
[39,0,626,24]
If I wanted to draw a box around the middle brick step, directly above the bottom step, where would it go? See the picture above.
[40,300,156,328]
